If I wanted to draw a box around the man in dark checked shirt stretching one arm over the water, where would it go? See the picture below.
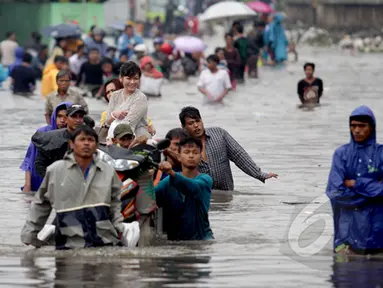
[179,107,278,190]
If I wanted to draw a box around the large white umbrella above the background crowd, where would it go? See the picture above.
[200,1,257,22]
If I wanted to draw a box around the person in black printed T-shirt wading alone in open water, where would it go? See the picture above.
[298,63,323,104]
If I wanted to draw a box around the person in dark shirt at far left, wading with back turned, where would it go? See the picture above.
[10,53,37,95]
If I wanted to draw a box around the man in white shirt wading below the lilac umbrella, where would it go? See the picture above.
[197,55,231,102]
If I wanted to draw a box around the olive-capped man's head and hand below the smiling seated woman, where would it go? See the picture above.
[112,123,149,149]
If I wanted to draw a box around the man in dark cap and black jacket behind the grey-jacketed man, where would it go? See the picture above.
[32,104,86,177]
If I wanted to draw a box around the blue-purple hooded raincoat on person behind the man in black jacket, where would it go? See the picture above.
[20,102,72,192]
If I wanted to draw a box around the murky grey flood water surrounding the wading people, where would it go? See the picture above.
[0,49,383,287]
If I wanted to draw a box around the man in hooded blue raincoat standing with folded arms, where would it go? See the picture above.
[326,106,383,254]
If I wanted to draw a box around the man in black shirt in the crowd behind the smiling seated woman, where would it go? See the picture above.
[77,48,103,98]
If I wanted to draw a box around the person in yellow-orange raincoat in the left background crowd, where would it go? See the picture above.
[41,56,69,97]
